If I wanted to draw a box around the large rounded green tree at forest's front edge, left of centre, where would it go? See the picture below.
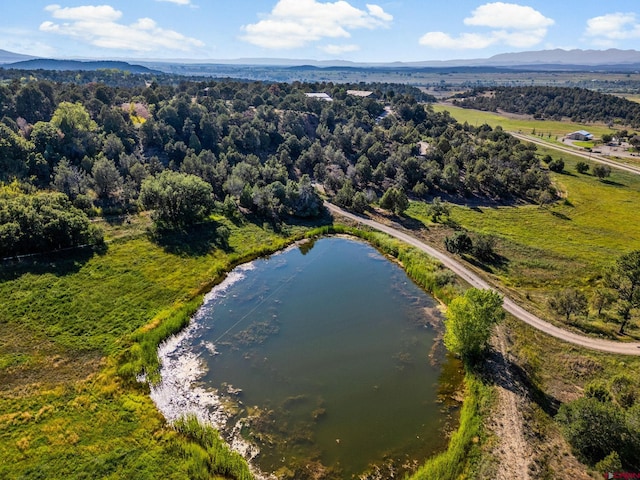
[140,170,213,230]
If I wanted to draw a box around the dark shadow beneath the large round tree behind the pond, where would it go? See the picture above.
[150,221,232,257]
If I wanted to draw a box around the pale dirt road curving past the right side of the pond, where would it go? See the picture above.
[324,202,640,356]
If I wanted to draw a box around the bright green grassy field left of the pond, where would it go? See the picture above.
[0,217,305,479]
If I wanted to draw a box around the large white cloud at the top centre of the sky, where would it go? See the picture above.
[241,0,393,48]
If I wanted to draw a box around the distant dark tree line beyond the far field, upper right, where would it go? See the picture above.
[454,87,640,128]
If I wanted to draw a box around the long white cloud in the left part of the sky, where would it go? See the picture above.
[40,5,204,52]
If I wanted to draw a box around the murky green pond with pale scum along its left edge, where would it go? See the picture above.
[152,237,461,479]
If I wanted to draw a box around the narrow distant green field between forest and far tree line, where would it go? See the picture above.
[433,104,615,140]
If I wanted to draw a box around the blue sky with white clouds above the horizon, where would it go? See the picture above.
[0,0,640,62]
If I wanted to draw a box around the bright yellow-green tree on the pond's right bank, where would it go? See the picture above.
[444,288,505,361]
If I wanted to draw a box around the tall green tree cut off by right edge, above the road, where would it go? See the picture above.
[605,250,640,335]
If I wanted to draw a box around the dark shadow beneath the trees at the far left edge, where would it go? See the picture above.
[0,244,102,282]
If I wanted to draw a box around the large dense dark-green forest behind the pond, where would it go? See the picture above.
[0,70,555,256]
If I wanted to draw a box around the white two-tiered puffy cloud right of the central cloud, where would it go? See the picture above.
[419,2,555,50]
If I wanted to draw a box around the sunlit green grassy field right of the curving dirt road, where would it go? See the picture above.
[407,148,640,336]
